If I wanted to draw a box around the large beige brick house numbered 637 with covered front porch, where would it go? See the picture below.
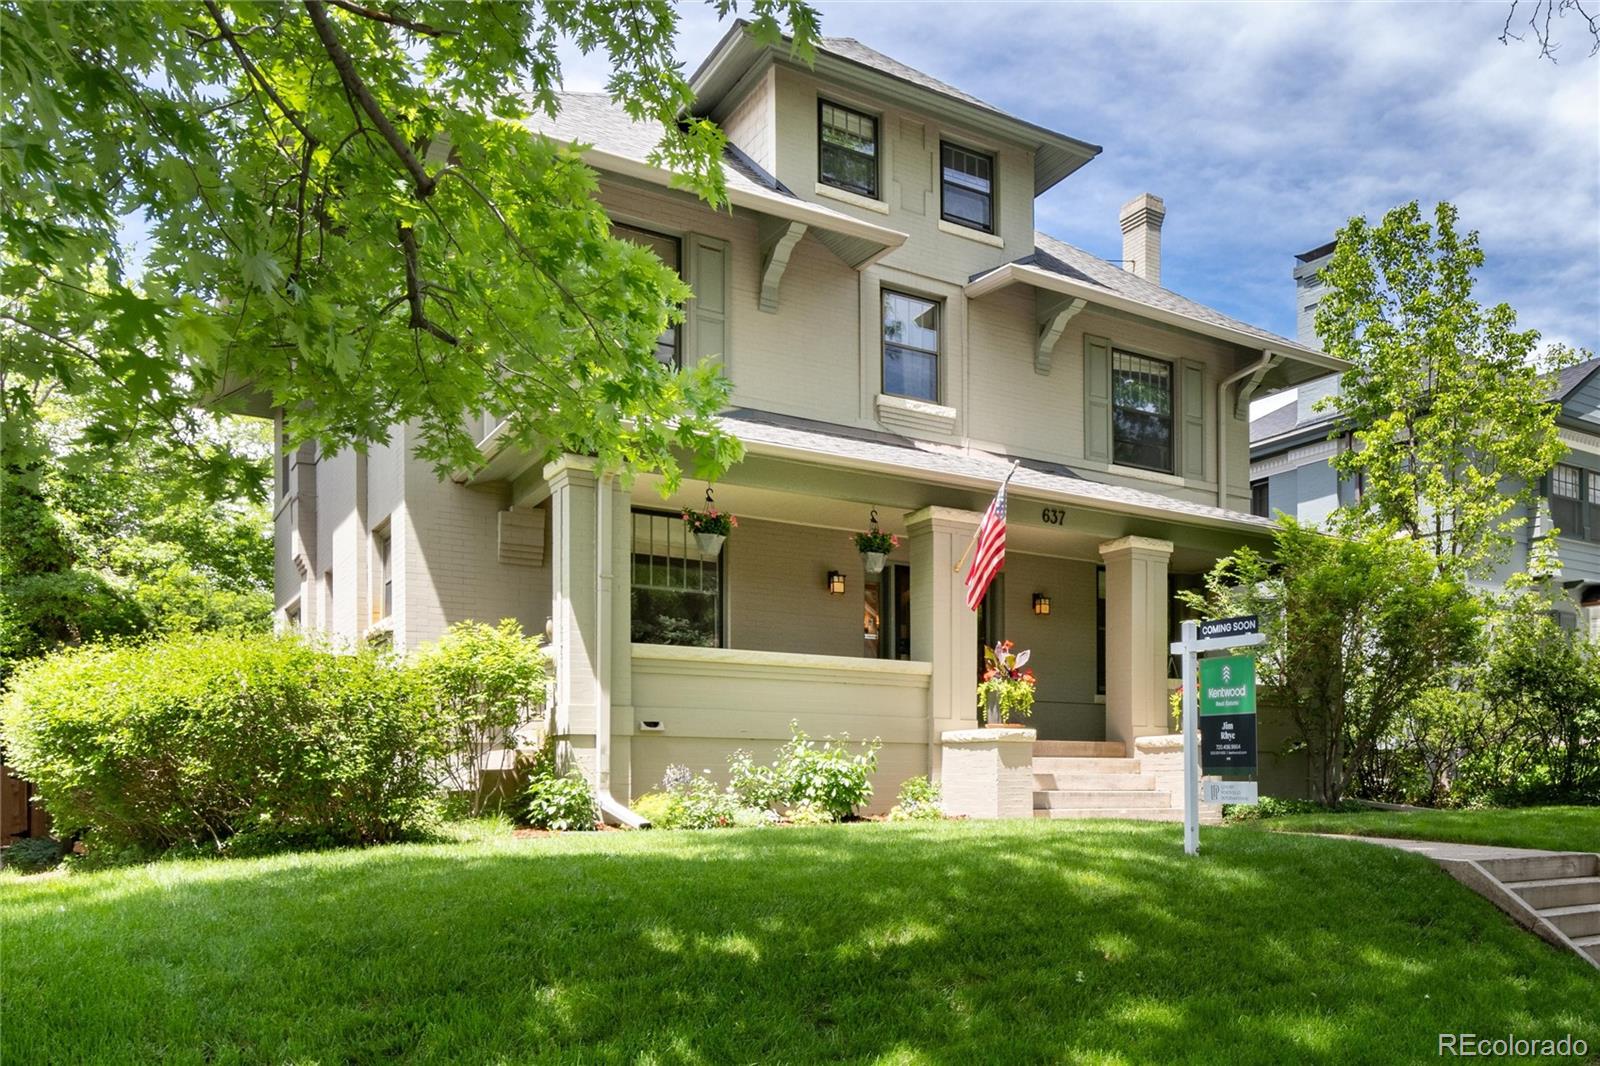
[277,24,1341,813]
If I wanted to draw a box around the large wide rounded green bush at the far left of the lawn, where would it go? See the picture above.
[0,634,438,847]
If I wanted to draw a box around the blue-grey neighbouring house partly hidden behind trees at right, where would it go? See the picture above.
[1250,243,1600,639]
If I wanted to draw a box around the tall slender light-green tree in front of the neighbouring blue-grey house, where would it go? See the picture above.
[1317,200,1576,578]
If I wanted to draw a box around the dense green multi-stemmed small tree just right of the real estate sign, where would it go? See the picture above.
[1184,517,1482,805]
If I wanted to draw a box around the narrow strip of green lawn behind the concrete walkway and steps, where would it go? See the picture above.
[1240,807,1600,852]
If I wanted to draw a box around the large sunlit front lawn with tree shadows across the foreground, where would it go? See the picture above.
[0,821,1600,1066]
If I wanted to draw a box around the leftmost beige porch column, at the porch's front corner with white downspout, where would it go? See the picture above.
[544,455,634,795]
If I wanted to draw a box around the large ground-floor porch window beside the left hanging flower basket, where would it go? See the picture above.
[632,511,722,648]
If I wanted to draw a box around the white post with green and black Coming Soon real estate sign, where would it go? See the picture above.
[1171,615,1267,855]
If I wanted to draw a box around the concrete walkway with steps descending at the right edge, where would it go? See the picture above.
[1317,832,1600,968]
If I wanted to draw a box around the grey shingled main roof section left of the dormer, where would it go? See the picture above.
[525,93,906,269]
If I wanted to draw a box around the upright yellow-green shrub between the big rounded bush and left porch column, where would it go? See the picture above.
[408,618,547,818]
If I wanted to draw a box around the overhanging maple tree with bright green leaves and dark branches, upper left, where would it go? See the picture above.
[0,0,816,483]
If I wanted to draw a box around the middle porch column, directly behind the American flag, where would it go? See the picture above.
[906,507,982,755]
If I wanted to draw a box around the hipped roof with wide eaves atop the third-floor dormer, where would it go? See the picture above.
[690,19,1101,195]
